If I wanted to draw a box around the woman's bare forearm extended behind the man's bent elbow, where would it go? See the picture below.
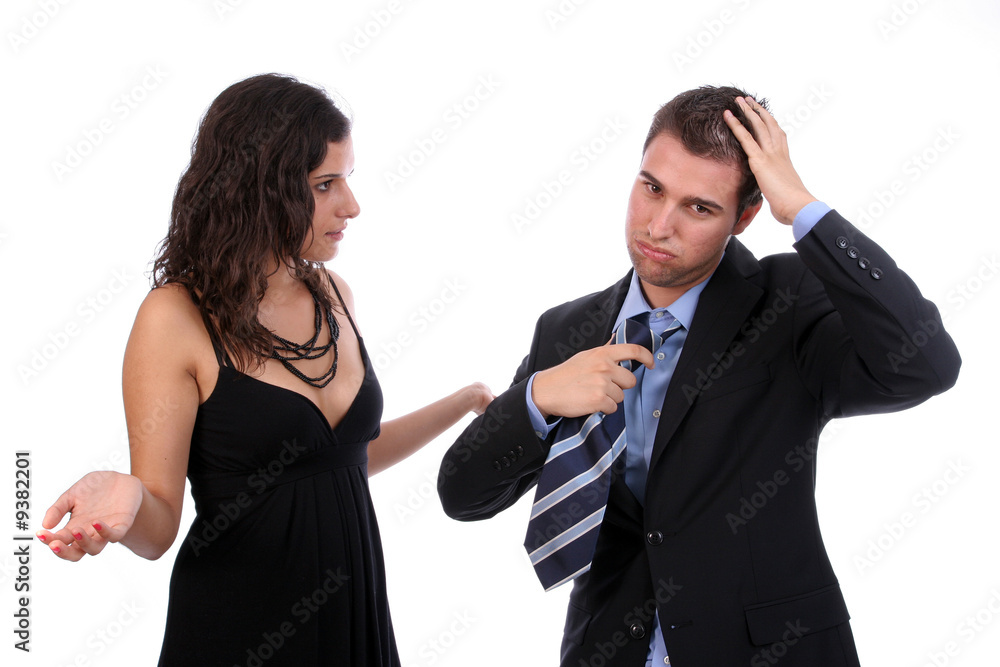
[368,382,494,476]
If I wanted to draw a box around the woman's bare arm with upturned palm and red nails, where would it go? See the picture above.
[37,285,207,561]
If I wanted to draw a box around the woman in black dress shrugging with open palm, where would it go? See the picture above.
[38,74,493,666]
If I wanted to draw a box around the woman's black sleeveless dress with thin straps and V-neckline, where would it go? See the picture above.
[159,294,399,667]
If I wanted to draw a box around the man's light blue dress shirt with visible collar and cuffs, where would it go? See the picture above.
[527,201,831,667]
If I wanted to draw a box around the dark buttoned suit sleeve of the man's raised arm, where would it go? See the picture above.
[794,211,961,418]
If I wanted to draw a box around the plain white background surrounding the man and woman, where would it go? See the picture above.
[0,0,1000,667]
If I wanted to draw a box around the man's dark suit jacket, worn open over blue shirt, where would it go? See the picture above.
[438,211,961,667]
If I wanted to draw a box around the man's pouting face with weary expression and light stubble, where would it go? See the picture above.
[625,134,760,308]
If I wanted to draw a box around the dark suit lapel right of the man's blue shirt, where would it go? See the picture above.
[649,237,764,470]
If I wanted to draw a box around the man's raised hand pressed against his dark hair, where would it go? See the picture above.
[723,97,816,225]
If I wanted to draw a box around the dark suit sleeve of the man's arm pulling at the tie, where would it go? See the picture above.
[438,316,550,521]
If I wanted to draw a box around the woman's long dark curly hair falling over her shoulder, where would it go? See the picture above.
[153,74,351,371]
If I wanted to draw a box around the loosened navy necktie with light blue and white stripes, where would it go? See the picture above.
[524,313,681,591]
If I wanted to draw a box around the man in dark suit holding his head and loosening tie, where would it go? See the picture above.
[438,87,961,667]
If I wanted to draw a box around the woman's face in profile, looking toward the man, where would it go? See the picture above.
[302,135,361,262]
